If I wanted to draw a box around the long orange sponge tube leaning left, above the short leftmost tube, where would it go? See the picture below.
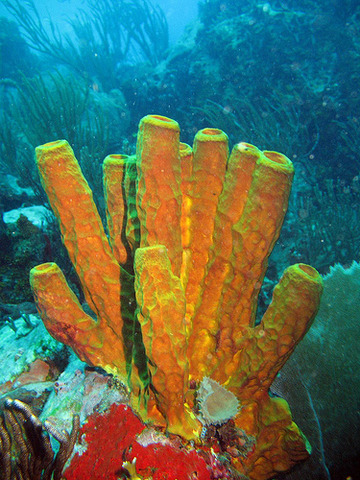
[36,140,125,336]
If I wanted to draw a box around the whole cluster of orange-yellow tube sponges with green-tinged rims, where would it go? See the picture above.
[30,115,322,480]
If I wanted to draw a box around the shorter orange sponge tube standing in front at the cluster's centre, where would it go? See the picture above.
[135,246,200,439]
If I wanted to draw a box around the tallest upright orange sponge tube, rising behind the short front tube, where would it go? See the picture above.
[136,115,182,275]
